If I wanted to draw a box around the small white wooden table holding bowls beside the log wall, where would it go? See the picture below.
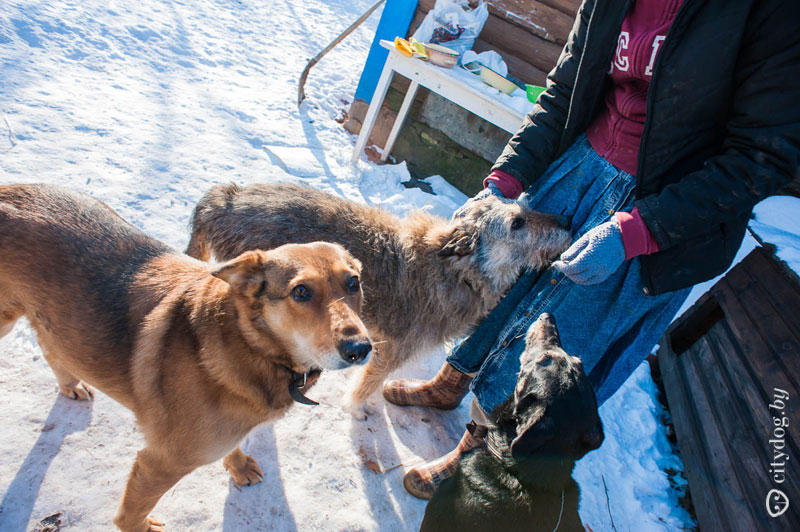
[352,40,526,163]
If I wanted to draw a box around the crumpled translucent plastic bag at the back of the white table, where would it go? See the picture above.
[414,0,489,54]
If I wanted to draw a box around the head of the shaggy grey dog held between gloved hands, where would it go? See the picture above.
[439,194,572,291]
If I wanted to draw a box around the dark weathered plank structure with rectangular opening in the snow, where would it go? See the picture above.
[658,248,800,531]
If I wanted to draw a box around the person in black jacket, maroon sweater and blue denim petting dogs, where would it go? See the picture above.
[384,0,800,498]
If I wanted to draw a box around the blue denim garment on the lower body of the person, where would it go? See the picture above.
[447,135,690,413]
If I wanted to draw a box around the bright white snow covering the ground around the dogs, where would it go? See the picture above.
[0,0,693,531]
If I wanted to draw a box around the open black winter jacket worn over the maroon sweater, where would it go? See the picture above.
[493,0,800,295]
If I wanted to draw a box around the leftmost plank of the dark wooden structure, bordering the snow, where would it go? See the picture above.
[658,334,725,523]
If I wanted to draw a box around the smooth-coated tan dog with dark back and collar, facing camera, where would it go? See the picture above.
[0,185,371,531]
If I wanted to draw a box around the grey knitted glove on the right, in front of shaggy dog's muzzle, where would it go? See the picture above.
[553,219,625,284]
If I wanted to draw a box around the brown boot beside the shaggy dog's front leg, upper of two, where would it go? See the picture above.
[383,362,472,410]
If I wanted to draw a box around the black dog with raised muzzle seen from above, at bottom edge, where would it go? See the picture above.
[420,314,603,532]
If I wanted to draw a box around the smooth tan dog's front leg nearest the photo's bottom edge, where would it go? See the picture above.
[114,447,195,532]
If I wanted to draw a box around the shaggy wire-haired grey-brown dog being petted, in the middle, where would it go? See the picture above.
[187,183,571,417]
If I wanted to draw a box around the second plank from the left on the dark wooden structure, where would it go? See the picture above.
[678,344,756,532]
